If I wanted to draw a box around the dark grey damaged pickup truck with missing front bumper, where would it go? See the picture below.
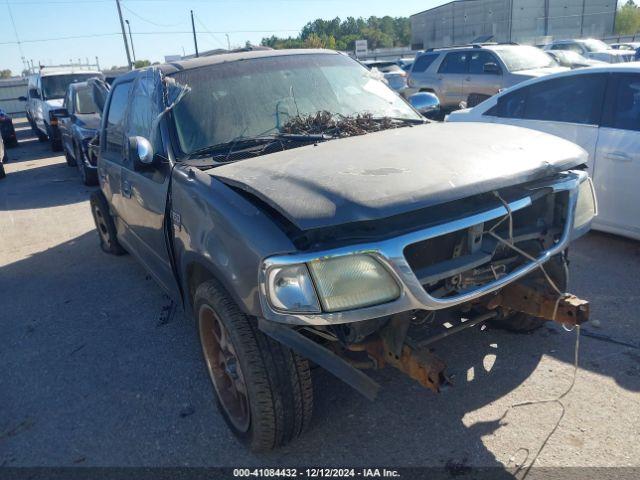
[91,50,596,450]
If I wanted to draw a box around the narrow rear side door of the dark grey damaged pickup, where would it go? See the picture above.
[98,80,132,227]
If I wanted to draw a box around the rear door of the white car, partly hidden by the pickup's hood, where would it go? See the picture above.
[495,74,606,168]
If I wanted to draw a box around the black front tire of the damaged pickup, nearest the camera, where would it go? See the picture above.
[194,281,313,452]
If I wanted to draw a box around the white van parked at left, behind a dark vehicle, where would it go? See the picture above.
[20,67,102,151]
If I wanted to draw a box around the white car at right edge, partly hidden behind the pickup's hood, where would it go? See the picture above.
[447,63,640,239]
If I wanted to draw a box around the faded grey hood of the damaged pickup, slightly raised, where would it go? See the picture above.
[208,123,587,230]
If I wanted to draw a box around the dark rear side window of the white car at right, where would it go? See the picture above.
[524,75,606,124]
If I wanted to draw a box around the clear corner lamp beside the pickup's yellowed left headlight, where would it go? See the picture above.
[267,264,320,313]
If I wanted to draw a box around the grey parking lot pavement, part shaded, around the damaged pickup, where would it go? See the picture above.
[0,121,640,471]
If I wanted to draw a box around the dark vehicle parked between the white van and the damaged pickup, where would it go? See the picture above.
[58,78,110,185]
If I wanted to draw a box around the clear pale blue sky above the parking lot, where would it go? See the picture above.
[0,0,446,73]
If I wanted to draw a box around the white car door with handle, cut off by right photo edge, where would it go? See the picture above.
[593,73,640,239]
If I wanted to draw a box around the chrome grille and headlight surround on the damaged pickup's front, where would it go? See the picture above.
[259,171,588,325]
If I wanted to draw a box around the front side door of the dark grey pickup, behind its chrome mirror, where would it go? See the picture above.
[119,70,179,298]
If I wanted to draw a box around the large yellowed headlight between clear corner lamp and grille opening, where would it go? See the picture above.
[309,255,400,312]
